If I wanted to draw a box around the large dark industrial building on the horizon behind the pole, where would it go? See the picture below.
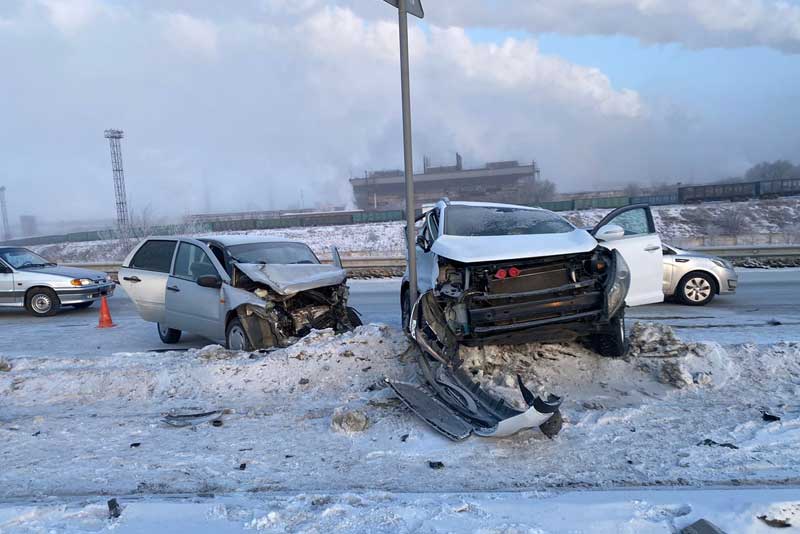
[350,154,539,210]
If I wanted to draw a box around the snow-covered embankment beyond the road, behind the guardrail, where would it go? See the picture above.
[26,198,800,263]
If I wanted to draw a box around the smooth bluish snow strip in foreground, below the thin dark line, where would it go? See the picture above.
[0,489,800,534]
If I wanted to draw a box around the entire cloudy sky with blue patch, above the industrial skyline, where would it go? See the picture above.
[0,0,800,225]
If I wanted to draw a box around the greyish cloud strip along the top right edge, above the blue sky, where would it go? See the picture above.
[426,0,800,53]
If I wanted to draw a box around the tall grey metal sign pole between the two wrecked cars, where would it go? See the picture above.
[397,0,417,306]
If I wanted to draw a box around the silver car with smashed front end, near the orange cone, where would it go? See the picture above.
[119,235,361,351]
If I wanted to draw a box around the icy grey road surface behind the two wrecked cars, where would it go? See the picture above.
[0,269,800,357]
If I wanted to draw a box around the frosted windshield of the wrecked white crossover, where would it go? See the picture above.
[444,206,575,236]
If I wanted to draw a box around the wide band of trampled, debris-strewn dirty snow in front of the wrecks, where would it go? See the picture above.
[0,324,800,506]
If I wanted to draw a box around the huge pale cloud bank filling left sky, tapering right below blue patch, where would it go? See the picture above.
[0,0,797,224]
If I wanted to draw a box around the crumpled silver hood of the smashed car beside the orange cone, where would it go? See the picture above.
[236,263,347,296]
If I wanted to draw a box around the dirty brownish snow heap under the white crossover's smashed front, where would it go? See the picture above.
[460,322,733,408]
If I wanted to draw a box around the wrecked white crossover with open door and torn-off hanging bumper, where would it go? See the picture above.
[389,199,664,439]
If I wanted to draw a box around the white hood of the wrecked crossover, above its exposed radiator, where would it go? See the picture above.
[431,229,597,263]
